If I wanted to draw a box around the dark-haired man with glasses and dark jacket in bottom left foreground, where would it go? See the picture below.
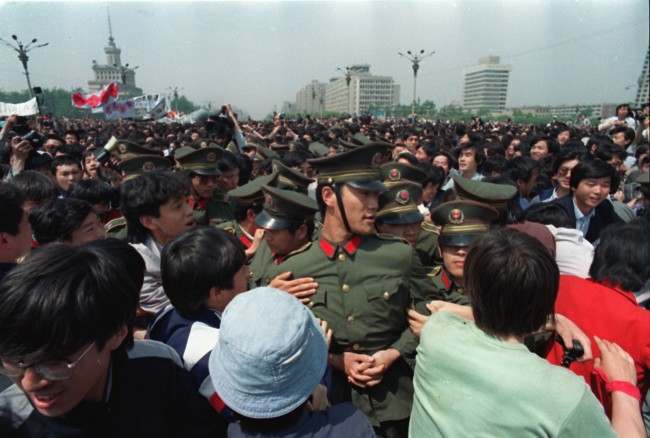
[0,240,223,438]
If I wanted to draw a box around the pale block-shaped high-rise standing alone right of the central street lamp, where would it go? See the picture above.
[463,56,511,111]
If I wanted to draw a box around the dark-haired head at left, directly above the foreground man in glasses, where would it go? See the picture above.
[29,198,106,245]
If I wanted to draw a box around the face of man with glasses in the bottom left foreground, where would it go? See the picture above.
[9,336,124,417]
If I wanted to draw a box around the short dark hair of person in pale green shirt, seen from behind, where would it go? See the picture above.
[463,228,560,337]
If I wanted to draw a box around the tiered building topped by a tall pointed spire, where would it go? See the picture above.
[88,9,142,97]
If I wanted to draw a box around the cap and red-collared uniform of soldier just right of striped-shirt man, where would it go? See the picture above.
[174,147,223,225]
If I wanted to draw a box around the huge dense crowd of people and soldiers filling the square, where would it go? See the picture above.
[0,104,650,438]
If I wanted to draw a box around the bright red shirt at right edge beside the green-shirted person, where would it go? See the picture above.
[547,275,650,415]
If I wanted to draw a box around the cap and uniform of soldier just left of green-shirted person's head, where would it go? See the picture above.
[429,200,499,305]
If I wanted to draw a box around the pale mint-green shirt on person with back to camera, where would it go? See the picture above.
[409,312,615,438]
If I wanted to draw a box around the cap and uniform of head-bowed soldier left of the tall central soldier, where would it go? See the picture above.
[251,186,318,286]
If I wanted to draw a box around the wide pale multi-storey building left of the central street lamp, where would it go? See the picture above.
[325,64,400,114]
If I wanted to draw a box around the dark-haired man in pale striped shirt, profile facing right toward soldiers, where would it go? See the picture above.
[120,171,196,320]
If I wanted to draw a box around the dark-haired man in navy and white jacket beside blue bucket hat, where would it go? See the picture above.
[149,227,249,420]
